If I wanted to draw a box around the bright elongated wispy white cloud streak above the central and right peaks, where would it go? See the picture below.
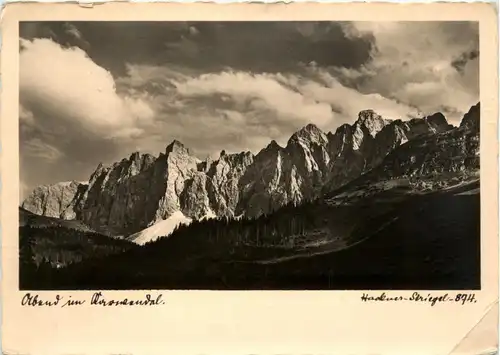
[176,67,418,130]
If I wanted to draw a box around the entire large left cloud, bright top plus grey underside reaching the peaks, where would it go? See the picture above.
[19,39,155,195]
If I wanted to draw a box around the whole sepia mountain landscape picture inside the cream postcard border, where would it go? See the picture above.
[16,18,480,290]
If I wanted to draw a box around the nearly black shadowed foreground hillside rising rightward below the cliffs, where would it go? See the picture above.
[23,182,480,290]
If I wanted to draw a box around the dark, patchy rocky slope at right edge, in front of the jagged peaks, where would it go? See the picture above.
[325,104,480,203]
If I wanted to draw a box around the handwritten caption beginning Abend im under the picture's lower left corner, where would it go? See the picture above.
[21,292,165,308]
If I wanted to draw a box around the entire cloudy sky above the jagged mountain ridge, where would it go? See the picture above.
[19,22,479,198]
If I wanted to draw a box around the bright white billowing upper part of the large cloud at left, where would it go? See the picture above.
[20,39,154,137]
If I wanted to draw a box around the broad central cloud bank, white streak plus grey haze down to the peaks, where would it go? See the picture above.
[117,64,418,156]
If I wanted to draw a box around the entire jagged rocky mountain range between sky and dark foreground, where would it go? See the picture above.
[22,104,480,242]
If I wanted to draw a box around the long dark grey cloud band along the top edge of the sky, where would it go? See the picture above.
[20,22,373,76]
